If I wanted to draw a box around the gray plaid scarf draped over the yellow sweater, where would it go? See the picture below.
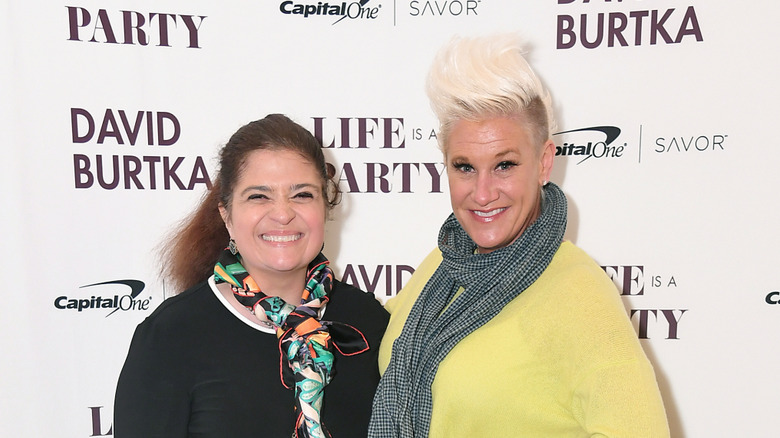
[369,183,566,438]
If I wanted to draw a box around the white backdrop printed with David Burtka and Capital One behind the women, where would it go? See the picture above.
[0,0,780,438]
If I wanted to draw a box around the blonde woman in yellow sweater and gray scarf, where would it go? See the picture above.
[369,35,669,438]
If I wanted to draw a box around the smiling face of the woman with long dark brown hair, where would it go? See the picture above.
[220,150,325,284]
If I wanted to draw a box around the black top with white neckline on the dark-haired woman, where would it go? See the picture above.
[114,281,389,438]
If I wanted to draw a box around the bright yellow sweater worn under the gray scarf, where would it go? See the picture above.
[379,242,669,438]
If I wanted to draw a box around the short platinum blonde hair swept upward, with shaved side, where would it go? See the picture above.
[426,34,554,152]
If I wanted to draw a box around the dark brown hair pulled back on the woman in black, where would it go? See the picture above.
[161,114,341,293]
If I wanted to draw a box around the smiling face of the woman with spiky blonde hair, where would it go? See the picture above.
[444,117,555,253]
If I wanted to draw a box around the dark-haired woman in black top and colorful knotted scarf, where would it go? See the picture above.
[114,114,388,438]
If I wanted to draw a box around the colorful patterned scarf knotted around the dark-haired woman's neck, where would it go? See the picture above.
[214,248,369,438]
